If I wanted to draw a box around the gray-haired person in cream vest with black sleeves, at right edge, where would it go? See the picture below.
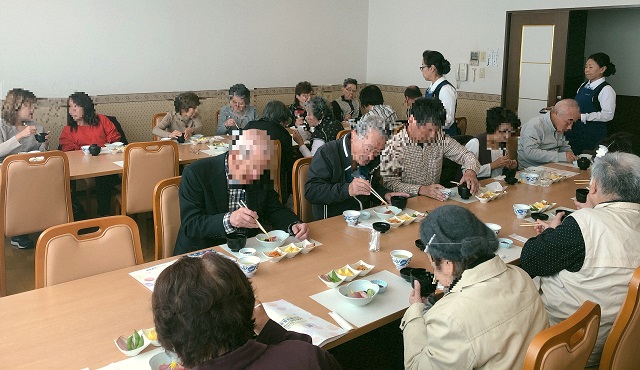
[520,152,640,366]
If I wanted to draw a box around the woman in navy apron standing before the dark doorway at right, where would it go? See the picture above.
[567,53,616,155]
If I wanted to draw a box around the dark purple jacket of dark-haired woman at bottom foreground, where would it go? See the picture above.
[192,320,342,370]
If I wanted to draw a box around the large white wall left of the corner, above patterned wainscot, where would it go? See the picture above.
[0,0,368,97]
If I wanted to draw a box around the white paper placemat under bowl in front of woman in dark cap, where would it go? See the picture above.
[311,270,411,327]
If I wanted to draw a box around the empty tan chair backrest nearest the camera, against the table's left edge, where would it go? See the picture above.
[35,216,144,289]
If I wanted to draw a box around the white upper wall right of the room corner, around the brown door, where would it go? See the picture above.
[367,0,640,94]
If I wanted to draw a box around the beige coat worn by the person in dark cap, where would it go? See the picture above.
[400,256,549,370]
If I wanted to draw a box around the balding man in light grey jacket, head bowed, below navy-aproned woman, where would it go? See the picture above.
[518,99,580,168]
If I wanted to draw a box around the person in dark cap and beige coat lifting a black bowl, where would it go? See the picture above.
[400,205,548,369]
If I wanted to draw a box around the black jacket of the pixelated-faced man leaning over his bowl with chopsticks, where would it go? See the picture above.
[173,154,300,255]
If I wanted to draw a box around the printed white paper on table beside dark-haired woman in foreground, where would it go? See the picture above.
[262,299,346,346]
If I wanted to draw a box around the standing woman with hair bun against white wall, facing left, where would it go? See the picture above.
[420,50,460,136]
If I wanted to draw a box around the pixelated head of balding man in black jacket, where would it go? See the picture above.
[229,130,273,185]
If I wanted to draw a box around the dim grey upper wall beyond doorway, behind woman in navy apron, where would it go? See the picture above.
[585,9,640,96]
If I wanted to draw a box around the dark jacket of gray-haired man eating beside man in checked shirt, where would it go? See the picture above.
[304,133,389,220]
